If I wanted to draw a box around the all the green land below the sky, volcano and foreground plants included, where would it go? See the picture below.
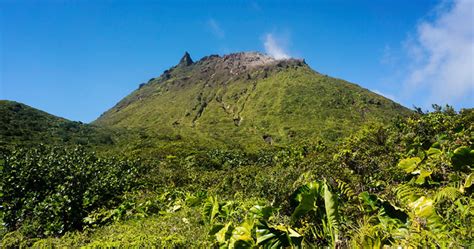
[0,53,468,248]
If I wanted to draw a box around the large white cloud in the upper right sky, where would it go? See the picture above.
[405,0,474,104]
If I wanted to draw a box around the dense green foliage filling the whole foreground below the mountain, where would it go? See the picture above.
[1,107,474,248]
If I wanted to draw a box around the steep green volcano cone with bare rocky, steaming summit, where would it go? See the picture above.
[94,52,410,148]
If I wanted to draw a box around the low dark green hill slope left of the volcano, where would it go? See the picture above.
[0,100,113,146]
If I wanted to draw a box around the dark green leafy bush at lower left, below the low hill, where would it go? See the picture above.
[0,146,142,236]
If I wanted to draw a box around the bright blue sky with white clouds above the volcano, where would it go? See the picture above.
[0,0,474,122]
